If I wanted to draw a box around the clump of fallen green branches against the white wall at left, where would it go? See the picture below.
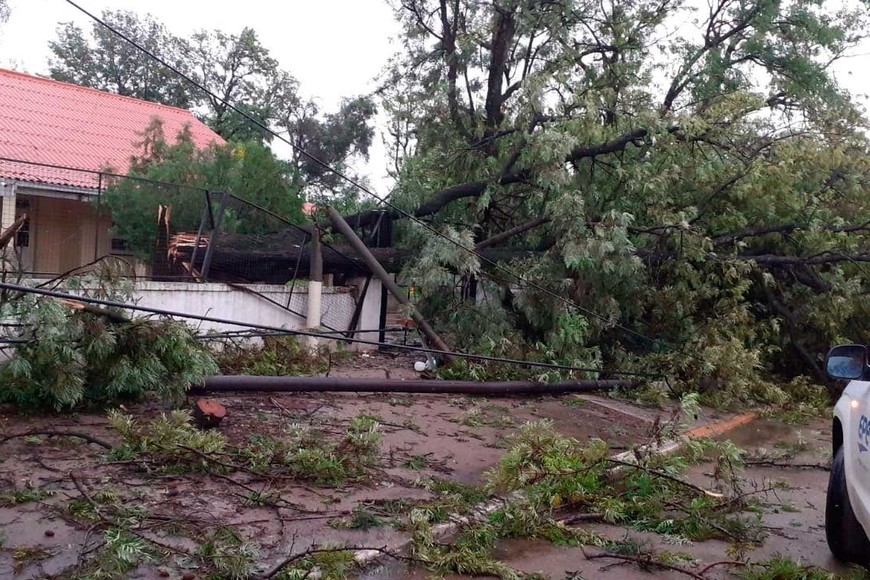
[0,280,218,410]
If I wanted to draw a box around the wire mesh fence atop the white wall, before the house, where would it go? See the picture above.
[0,158,392,340]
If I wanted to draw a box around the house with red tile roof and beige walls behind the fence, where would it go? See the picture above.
[0,69,224,274]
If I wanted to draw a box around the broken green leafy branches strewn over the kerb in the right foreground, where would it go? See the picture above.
[407,414,763,578]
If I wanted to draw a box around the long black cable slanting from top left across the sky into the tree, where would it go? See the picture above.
[64,0,674,348]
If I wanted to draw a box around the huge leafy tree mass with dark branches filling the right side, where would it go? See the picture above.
[381,0,870,403]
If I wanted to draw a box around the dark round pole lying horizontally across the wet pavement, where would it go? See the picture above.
[191,375,640,395]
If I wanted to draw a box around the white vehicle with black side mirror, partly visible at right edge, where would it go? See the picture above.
[825,344,870,566]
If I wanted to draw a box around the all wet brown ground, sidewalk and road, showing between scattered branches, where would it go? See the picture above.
[0,346,843,579]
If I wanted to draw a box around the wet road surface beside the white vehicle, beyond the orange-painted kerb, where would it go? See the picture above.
[365,421,849,580]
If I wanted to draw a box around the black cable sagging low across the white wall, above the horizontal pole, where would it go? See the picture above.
[0,282,660,379]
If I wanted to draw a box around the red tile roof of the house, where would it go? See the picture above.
[0,69,224,189]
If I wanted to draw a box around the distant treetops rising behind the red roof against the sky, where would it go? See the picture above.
[50,10,376,193]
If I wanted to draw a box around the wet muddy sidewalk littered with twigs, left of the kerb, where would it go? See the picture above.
[0,382,651,579]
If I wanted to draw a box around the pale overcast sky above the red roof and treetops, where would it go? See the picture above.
[0,0,870,194]
